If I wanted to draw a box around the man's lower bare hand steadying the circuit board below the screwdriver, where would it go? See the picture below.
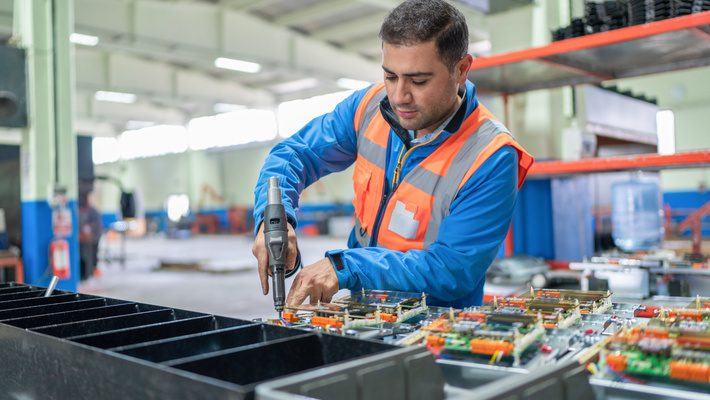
[286,258,340,307]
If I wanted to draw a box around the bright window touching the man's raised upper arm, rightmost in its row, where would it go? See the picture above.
[276,90,353,137]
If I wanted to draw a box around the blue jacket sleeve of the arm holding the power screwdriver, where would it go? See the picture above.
[254,89,367,232]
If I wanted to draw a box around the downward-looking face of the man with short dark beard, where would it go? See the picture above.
[382,40,471,134]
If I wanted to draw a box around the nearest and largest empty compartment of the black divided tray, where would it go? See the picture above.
[170,333,395,391]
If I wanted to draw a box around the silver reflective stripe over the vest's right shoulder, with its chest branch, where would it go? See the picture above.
[403,119,508,249]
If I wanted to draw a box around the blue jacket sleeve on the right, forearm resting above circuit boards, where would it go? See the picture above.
[326,146,518,302]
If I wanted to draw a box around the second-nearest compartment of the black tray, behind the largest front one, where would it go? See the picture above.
[114,324,303,362]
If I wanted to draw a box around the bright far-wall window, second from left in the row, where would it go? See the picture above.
[118,125,187,160]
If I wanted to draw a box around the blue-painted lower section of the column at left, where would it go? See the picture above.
[22,200,79,292]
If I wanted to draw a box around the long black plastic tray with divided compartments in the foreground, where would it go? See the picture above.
[0,283,443,399]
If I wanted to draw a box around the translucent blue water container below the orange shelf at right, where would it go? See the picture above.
[611,180,663,251]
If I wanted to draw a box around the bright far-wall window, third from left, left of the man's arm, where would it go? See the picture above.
[188,110,276,150]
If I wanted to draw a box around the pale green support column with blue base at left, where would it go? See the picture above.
[14,0,79,291]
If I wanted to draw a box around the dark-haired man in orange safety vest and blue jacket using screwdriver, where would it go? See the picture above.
[252,0,533,307]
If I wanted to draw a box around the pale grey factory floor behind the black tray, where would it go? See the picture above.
[79,235,346,319]
